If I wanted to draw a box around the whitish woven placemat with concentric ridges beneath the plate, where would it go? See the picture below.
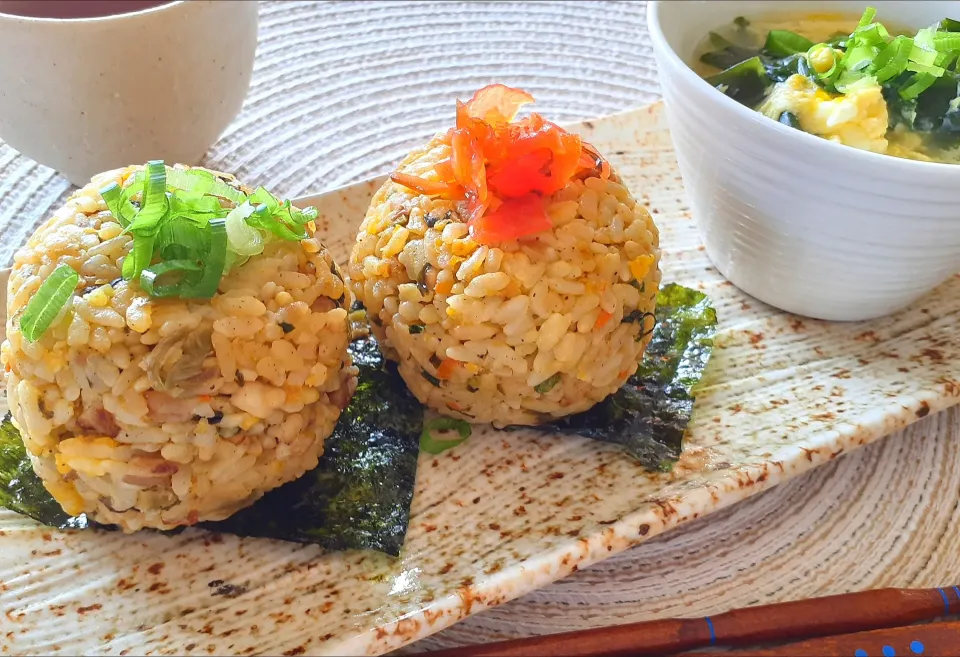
[0,1,960,653]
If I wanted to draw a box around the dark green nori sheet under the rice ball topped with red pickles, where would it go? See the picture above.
[510,284,717,470]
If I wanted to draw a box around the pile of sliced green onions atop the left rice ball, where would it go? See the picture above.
[100,160,317,299]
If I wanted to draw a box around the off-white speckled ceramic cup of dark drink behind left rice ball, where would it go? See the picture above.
[0,0,257,185]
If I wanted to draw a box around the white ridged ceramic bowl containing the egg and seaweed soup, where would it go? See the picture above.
[647,0,960,320]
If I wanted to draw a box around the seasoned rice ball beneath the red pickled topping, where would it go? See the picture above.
[348,137,660,426]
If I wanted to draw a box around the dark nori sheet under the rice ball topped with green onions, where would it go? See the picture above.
[0,337,423,556]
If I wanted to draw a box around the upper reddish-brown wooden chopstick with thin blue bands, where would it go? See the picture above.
[423,586,960,657]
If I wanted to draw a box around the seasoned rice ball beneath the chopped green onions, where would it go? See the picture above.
[0,166,356,531]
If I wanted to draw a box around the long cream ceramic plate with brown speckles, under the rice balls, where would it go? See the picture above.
[0,105,960,655]
